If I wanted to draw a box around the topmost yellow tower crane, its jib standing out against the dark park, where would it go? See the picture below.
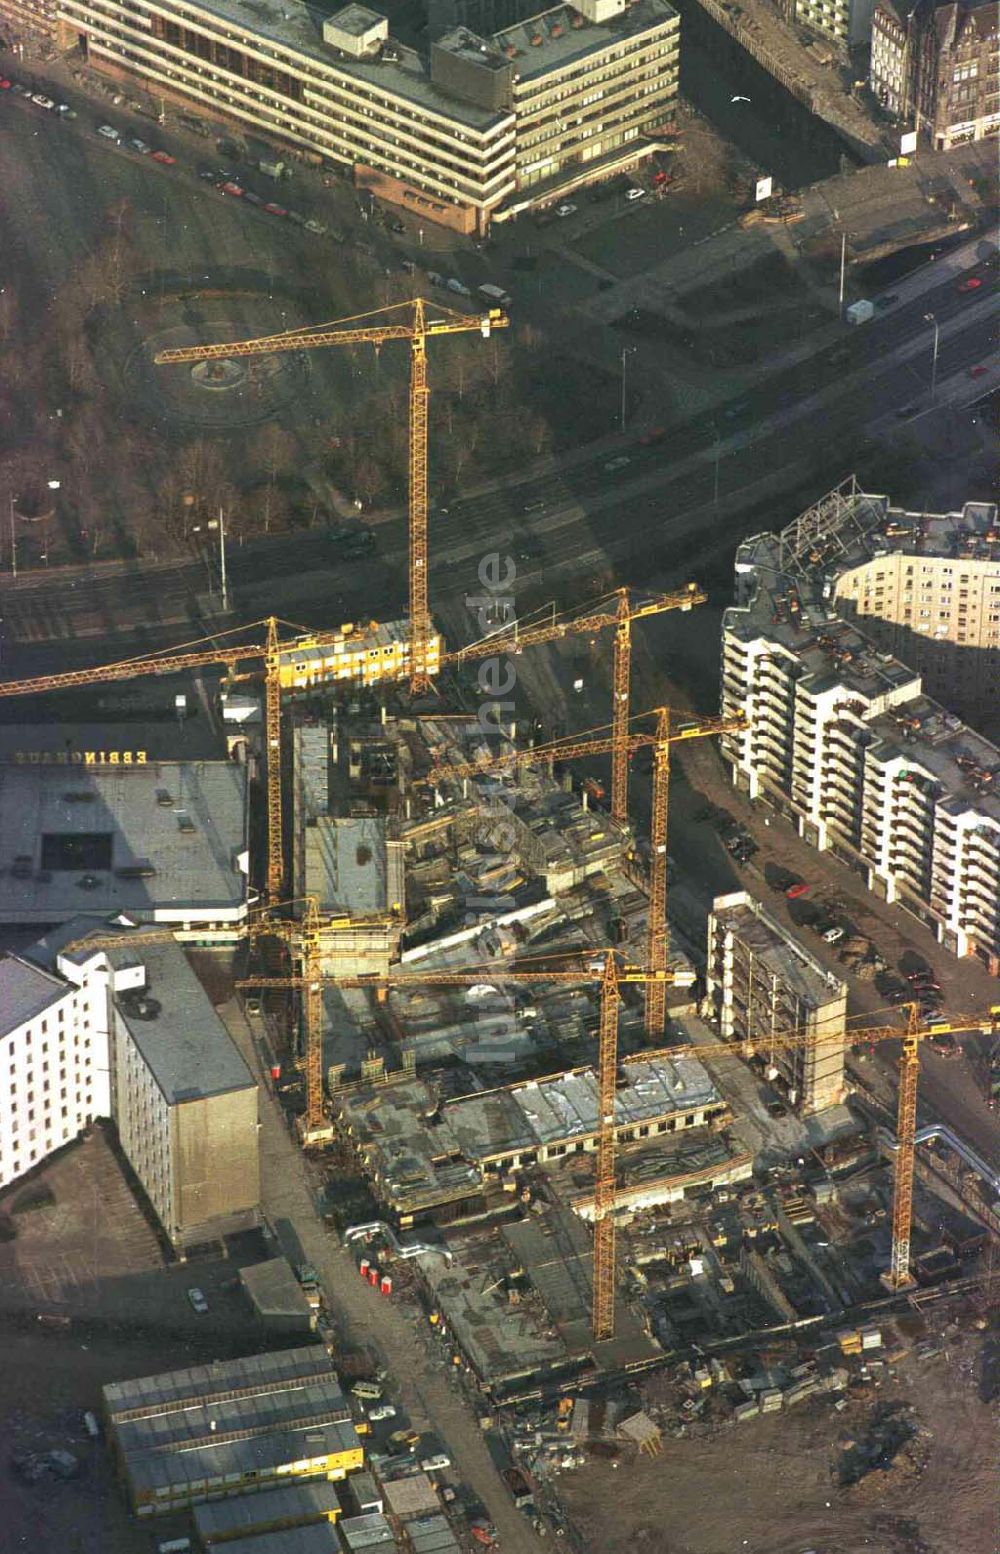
[154,297,508,693]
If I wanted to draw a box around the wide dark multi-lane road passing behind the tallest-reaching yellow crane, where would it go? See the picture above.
[2,269,994,674]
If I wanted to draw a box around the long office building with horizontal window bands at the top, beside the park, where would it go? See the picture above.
[17,0,679,233]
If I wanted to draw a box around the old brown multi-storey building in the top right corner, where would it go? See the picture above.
[870,0,1000,151]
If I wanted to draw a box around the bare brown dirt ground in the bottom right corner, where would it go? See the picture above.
[559,1333,1000,1554]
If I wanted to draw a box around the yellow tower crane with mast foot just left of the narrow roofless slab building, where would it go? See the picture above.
[425,707,745,1040]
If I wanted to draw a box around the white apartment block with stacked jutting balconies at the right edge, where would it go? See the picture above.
[722,482,1000,971]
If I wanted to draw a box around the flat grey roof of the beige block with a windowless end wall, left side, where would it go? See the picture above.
[115,939,256,1105]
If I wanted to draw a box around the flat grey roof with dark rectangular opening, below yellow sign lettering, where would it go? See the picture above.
[0,752,247,923]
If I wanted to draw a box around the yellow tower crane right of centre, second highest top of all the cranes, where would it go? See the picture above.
[441,583,708,825]
